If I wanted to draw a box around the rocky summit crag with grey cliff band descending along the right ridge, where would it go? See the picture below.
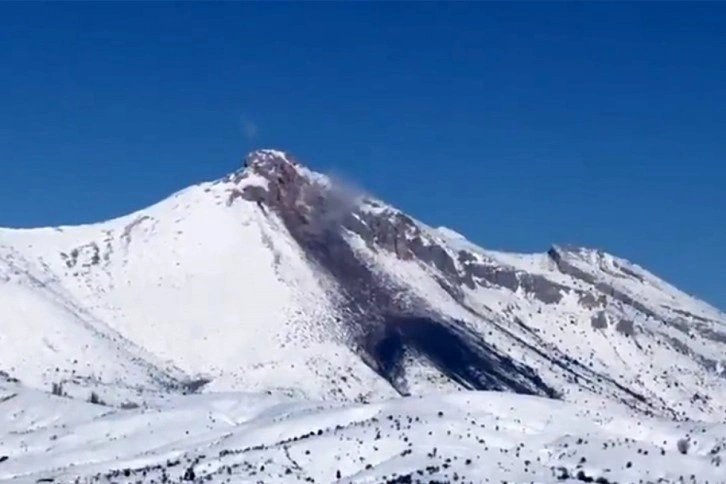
[239,152,566,304]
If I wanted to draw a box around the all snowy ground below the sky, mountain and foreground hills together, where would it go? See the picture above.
[0,150,726,484]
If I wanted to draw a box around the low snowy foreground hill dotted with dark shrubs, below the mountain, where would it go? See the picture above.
[0,383,726,484]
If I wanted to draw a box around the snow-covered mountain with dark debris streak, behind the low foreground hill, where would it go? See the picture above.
[0,150,726,421]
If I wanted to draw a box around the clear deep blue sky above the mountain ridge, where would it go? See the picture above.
[0,2,726,308]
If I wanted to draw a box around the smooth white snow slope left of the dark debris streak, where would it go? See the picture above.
[0,173,394,398]
